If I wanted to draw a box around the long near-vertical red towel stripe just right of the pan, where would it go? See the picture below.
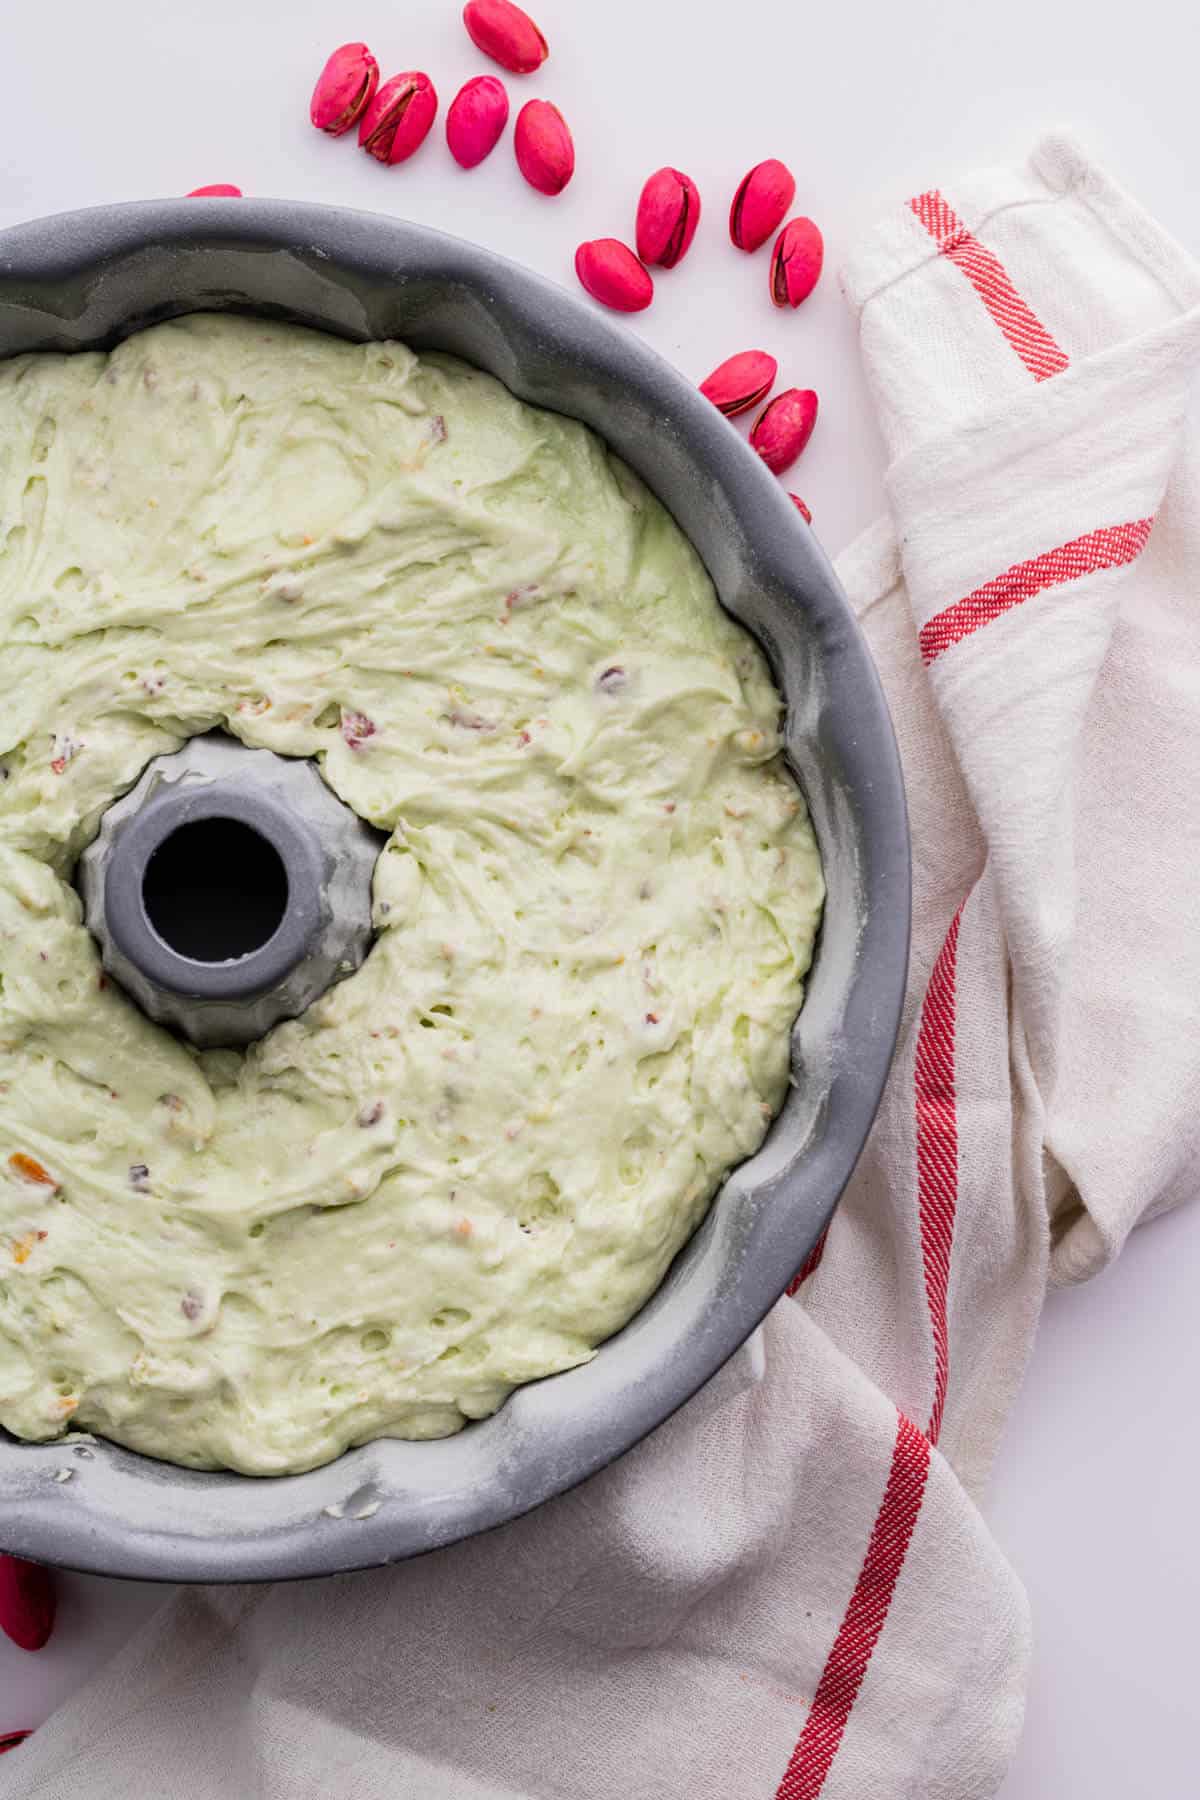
[912,902,966,1444]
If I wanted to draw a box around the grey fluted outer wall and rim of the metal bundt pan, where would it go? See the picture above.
[0,200,909,1580]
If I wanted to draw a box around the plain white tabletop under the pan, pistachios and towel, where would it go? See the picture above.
[0,0,1200,1800]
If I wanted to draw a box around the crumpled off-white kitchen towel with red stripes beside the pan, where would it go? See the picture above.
[0,139,1200,1800]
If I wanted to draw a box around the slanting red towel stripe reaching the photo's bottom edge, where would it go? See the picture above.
[775,1413,930,1800]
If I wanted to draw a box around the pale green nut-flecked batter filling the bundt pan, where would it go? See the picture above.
[0,317,824,1474]
